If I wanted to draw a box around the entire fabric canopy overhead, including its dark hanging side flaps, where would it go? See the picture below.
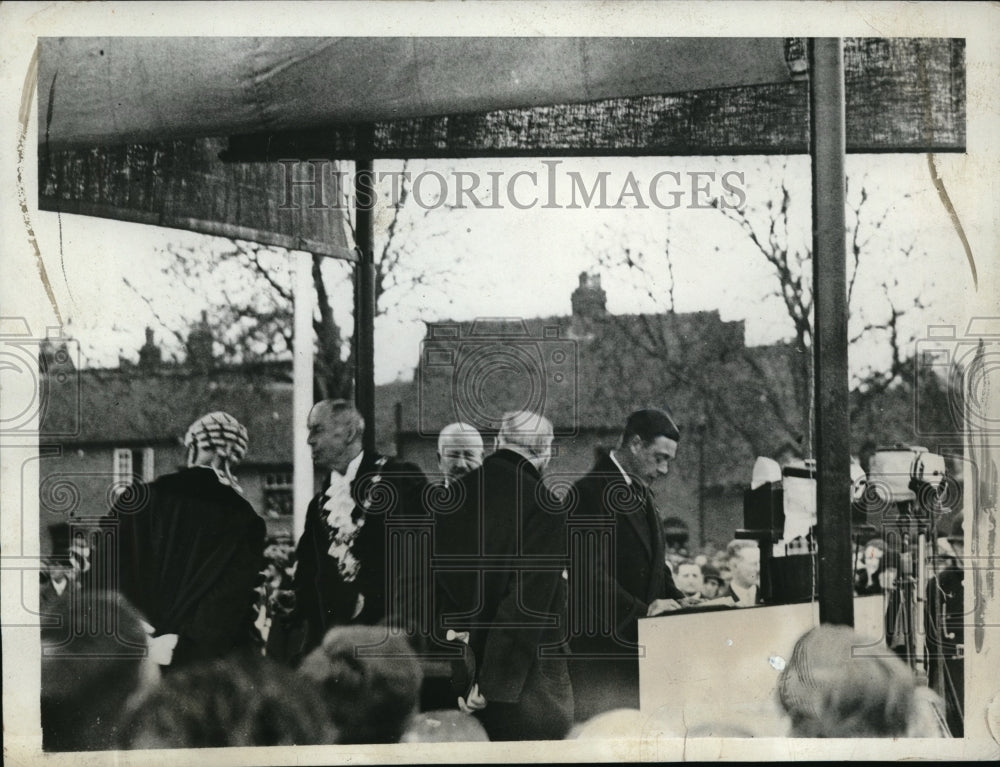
[38,37,965,260]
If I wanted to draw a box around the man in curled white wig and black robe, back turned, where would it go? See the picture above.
[108,411,266,668]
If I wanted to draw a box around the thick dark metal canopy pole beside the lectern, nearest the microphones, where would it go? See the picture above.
[809,38,854,626]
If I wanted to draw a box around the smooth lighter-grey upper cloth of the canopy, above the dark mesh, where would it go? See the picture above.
[38,37,802,150]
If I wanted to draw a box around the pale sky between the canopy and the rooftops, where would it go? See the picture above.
[38,155,969,390]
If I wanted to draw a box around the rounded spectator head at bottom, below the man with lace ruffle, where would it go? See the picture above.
[299,626,423,743]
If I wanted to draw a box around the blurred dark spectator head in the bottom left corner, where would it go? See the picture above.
[41,592,159,751]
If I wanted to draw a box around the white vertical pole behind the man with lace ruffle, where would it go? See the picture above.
[292,251,316,541]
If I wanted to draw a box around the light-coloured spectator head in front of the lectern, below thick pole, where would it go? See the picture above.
[778,624,916,738]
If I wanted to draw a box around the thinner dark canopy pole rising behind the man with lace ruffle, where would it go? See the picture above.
[354,125,376,451]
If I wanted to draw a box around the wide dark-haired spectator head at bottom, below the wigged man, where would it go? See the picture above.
[120,657,337,749]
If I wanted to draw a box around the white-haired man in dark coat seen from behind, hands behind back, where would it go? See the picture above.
[433,411,573,740]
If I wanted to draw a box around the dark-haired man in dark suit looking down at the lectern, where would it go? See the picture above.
[568,410,685,721]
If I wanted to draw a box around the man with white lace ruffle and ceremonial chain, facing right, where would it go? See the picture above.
[279,400,425,662]
